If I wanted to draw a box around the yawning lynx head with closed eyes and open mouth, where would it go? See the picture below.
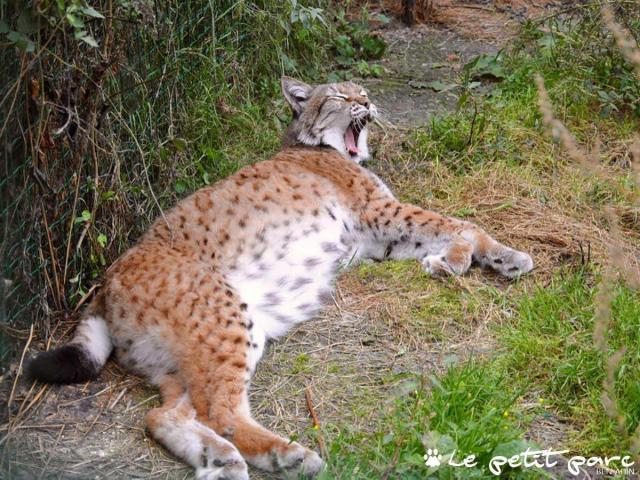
[282,77,378,163]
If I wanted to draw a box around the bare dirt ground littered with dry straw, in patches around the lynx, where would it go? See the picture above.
[0,0,604,479]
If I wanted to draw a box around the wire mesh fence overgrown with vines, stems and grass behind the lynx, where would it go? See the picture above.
[0,0,326,365]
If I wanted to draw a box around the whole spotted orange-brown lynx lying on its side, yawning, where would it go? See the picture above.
[28,77,533,480]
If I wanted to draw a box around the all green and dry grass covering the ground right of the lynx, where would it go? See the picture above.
[320,2,640,479]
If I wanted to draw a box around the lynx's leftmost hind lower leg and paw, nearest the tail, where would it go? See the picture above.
[146,375,249,480]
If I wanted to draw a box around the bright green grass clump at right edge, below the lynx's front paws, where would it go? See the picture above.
[499,271,640,454]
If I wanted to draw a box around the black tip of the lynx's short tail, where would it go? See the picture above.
[25,345,99,385]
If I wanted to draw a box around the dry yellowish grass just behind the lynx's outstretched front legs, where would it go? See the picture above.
[370,129,640,280]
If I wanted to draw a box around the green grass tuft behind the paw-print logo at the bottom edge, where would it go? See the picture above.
[325,361,535,479]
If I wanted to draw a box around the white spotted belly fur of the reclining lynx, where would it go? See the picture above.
[228,206,356,370]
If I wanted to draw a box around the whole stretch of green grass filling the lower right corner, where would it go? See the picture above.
[326,271,640,479]
